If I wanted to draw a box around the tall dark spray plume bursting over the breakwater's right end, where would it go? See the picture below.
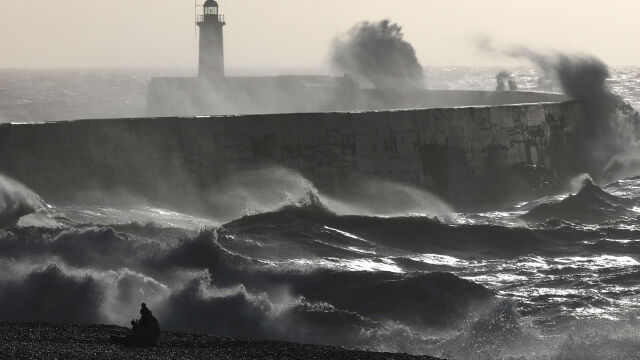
[477,39,640,177]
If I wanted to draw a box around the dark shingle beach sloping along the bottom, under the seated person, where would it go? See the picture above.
[0,321,444,360]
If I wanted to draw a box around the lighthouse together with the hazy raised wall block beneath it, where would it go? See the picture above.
[148,0,352,115]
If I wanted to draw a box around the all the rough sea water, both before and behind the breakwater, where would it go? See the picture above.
[0,68,640,359]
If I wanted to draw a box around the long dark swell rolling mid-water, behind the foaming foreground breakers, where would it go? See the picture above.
[219,203,637,258]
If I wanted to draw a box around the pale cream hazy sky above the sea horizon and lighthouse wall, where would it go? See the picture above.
[0,0,640,68]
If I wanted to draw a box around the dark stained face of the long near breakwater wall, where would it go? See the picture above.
[0,97,584,205]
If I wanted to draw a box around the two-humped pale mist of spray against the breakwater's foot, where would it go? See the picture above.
[202,166,453,220]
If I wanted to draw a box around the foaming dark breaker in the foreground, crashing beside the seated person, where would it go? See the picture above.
[0,227,495,352]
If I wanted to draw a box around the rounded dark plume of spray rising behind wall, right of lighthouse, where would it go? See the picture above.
[331,20,424,91]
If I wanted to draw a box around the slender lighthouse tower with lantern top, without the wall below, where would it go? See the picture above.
[197,0,225,82]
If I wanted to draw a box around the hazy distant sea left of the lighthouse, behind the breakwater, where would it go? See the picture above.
[0,69,194,123]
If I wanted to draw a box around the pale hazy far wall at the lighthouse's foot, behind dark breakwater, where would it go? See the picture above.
[147,76,569,117]
